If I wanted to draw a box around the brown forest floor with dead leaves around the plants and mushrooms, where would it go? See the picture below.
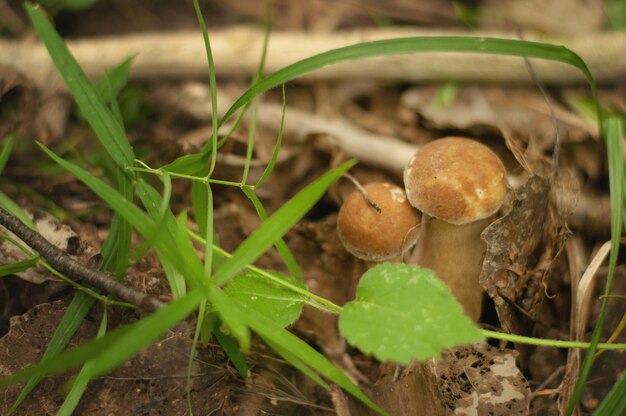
[0,0,626,416]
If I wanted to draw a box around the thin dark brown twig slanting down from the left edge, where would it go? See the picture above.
[0,208,165,311]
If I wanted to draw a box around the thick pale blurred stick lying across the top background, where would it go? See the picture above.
[0,26,626,87]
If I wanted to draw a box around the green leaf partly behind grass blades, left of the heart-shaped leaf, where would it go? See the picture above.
[224,270,305,327]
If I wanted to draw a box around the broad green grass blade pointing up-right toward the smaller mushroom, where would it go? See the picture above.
[215,162,354,285]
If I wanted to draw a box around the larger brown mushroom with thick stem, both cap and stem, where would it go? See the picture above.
[404,137,507,321]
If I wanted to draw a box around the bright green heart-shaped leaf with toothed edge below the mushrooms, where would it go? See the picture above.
[339,263,484,364]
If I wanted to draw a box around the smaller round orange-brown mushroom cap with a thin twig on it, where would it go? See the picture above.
[337,182,418,261]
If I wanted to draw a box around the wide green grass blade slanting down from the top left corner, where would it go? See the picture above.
[25,3,134,168]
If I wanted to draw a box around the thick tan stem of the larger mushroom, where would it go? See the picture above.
[411,214,489,321]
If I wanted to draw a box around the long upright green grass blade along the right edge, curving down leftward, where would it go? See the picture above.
[565,117,625,416]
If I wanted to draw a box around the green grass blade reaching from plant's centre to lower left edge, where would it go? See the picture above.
[0,290,205,387]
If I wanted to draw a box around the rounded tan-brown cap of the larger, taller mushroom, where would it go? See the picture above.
[404,137,506,225]
